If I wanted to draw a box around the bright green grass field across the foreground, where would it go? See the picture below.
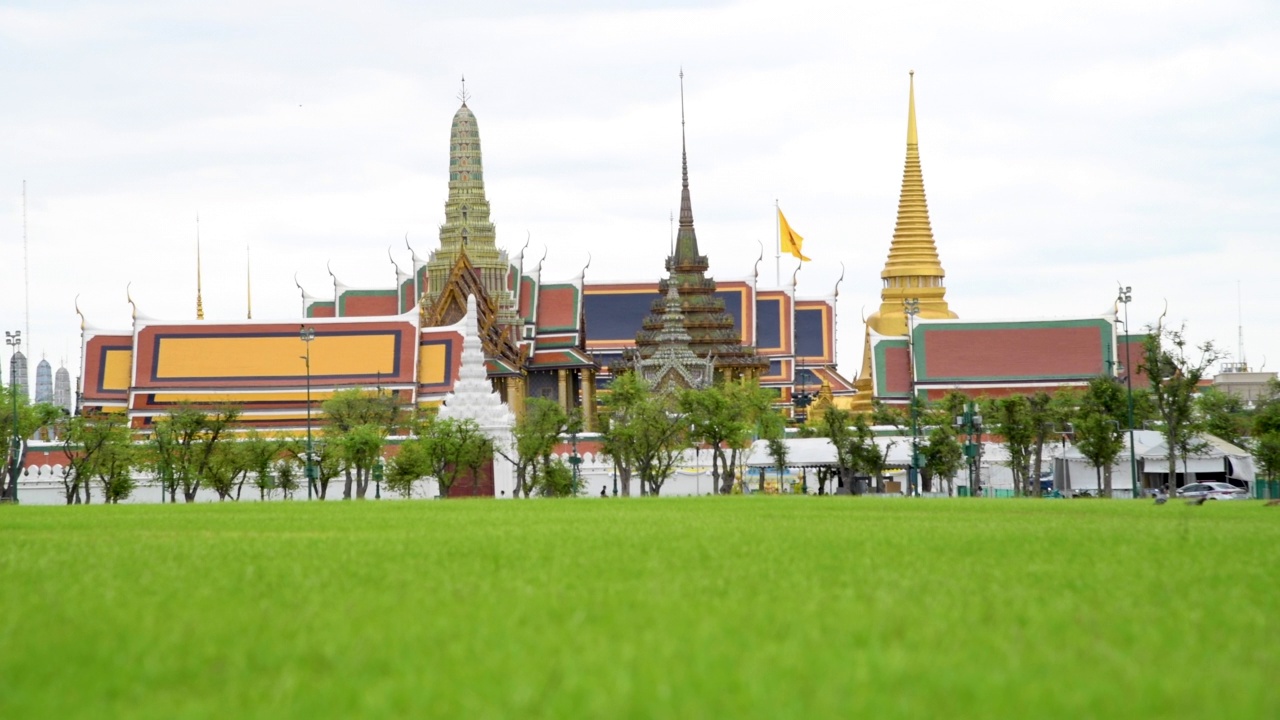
[0,497,1280,719]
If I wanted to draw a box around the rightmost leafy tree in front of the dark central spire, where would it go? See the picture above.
[680,378,771,493]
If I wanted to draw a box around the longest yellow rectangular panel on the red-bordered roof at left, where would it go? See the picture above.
[156,332,397,379]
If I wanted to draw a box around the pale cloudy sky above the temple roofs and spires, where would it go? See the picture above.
[0,0,1280,382]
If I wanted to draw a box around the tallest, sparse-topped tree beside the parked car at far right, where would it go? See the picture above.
[1142,325,1222,492]
